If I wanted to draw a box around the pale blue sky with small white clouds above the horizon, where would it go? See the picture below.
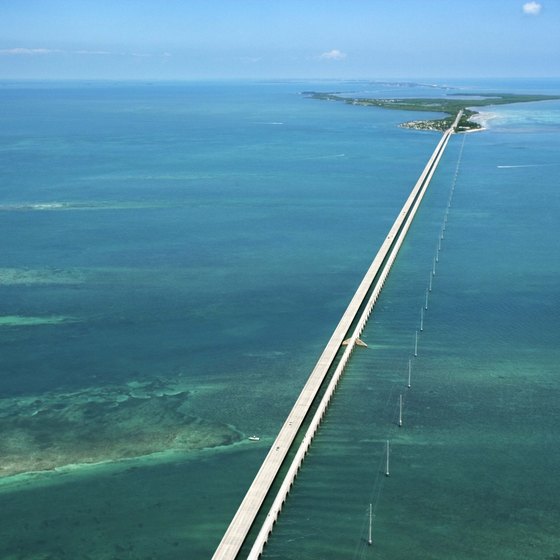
[0,0,560,80]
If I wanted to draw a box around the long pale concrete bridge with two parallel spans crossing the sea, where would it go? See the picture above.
[212,111,462,560]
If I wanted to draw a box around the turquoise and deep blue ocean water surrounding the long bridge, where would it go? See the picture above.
[0,80,560,560]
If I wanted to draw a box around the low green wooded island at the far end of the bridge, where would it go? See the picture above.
[302,91,560,132]
